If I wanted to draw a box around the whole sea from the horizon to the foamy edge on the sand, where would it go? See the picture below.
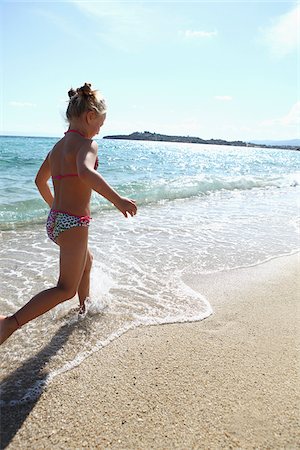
[0,137,300,406]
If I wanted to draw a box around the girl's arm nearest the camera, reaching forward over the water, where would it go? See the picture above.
[77,141,137,217]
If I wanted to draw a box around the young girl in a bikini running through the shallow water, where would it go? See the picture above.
[0,83,137,344]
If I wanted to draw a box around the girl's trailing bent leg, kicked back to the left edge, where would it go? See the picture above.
[0,227,88,344]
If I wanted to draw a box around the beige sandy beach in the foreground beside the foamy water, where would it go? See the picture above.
[2,254,300,450]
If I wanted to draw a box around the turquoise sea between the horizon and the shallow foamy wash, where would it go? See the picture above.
[0,137,300,230]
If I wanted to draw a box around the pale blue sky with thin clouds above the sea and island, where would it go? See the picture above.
[0,0,300,141]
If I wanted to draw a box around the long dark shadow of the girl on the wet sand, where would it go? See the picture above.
[0,322,77,450]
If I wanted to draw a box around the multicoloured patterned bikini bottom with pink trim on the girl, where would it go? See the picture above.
[46,209,91,244]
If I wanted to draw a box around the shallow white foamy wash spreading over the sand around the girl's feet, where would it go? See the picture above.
[0,182,299,402]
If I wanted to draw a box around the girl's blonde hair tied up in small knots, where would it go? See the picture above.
[66,83,106,121]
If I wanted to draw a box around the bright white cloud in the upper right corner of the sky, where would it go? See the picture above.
[261,3,300,58]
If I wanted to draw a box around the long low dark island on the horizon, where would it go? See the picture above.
[103,131,300,150]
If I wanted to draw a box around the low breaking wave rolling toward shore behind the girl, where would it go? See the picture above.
[0,172,300,231]
